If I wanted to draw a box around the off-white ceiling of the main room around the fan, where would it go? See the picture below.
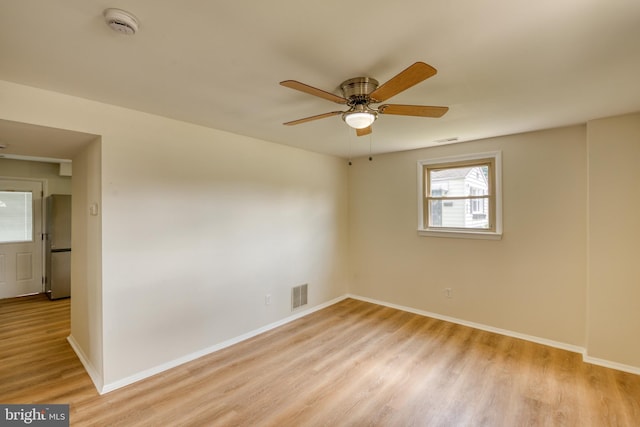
[0,0,640,157]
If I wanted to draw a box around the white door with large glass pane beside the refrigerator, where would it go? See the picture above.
[0,179,43,298]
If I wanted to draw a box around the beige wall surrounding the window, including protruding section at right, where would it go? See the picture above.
[349,114,640,373]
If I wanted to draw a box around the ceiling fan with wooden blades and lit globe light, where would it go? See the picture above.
[280,62,449,136]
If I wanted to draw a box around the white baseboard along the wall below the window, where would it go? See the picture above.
[348,295,585,355]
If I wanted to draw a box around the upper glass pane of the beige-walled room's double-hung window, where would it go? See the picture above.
[429,165,489,197]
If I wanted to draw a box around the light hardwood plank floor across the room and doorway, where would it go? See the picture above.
[0,296,640,427]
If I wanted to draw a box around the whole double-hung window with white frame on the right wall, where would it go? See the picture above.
[418,152,502,239]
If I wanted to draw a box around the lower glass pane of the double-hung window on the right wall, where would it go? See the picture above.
[429,199,489,229]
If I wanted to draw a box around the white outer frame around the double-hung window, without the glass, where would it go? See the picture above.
[418,151,502,240]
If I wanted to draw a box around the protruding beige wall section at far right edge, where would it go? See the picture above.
[587,114,640,367]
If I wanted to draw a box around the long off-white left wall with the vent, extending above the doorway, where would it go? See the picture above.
[0,81,348,389]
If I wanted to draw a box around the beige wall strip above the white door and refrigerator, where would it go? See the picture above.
[0,159,71,196]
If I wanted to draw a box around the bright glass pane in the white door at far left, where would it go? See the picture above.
[0,191,33,243]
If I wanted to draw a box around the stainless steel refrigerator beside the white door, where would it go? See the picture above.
[45,194,71,299]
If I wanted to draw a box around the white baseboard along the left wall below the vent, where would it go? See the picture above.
[100,295,348,394]
